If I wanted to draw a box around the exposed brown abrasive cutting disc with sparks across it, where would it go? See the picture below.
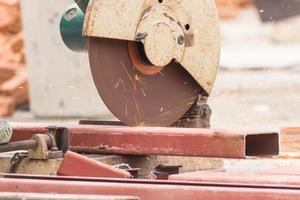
[88,38,202,126]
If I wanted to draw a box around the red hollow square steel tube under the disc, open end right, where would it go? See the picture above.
[70,126,279,158]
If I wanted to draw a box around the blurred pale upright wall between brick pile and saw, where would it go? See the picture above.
[21,0,110,118]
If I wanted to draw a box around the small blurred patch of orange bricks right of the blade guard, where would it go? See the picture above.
[215,0,254,19]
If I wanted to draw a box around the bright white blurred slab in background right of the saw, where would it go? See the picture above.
[220,8,300,69]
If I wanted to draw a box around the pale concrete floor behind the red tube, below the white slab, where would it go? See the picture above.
[7,69,300,130]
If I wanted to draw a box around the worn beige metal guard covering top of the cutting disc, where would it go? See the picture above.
[83,0,220,95]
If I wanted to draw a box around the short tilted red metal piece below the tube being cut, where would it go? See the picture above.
[57,151,130,178]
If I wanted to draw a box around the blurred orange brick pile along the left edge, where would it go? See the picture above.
[0,0,28,117]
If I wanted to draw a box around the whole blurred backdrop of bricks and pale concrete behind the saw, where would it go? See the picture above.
[0,0,300,130]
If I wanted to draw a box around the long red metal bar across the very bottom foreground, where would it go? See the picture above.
[0,175,300,200]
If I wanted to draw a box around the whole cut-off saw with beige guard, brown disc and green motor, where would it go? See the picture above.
[60,0,220,126]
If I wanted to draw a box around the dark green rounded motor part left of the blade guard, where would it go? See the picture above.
[60,4,88,52]
